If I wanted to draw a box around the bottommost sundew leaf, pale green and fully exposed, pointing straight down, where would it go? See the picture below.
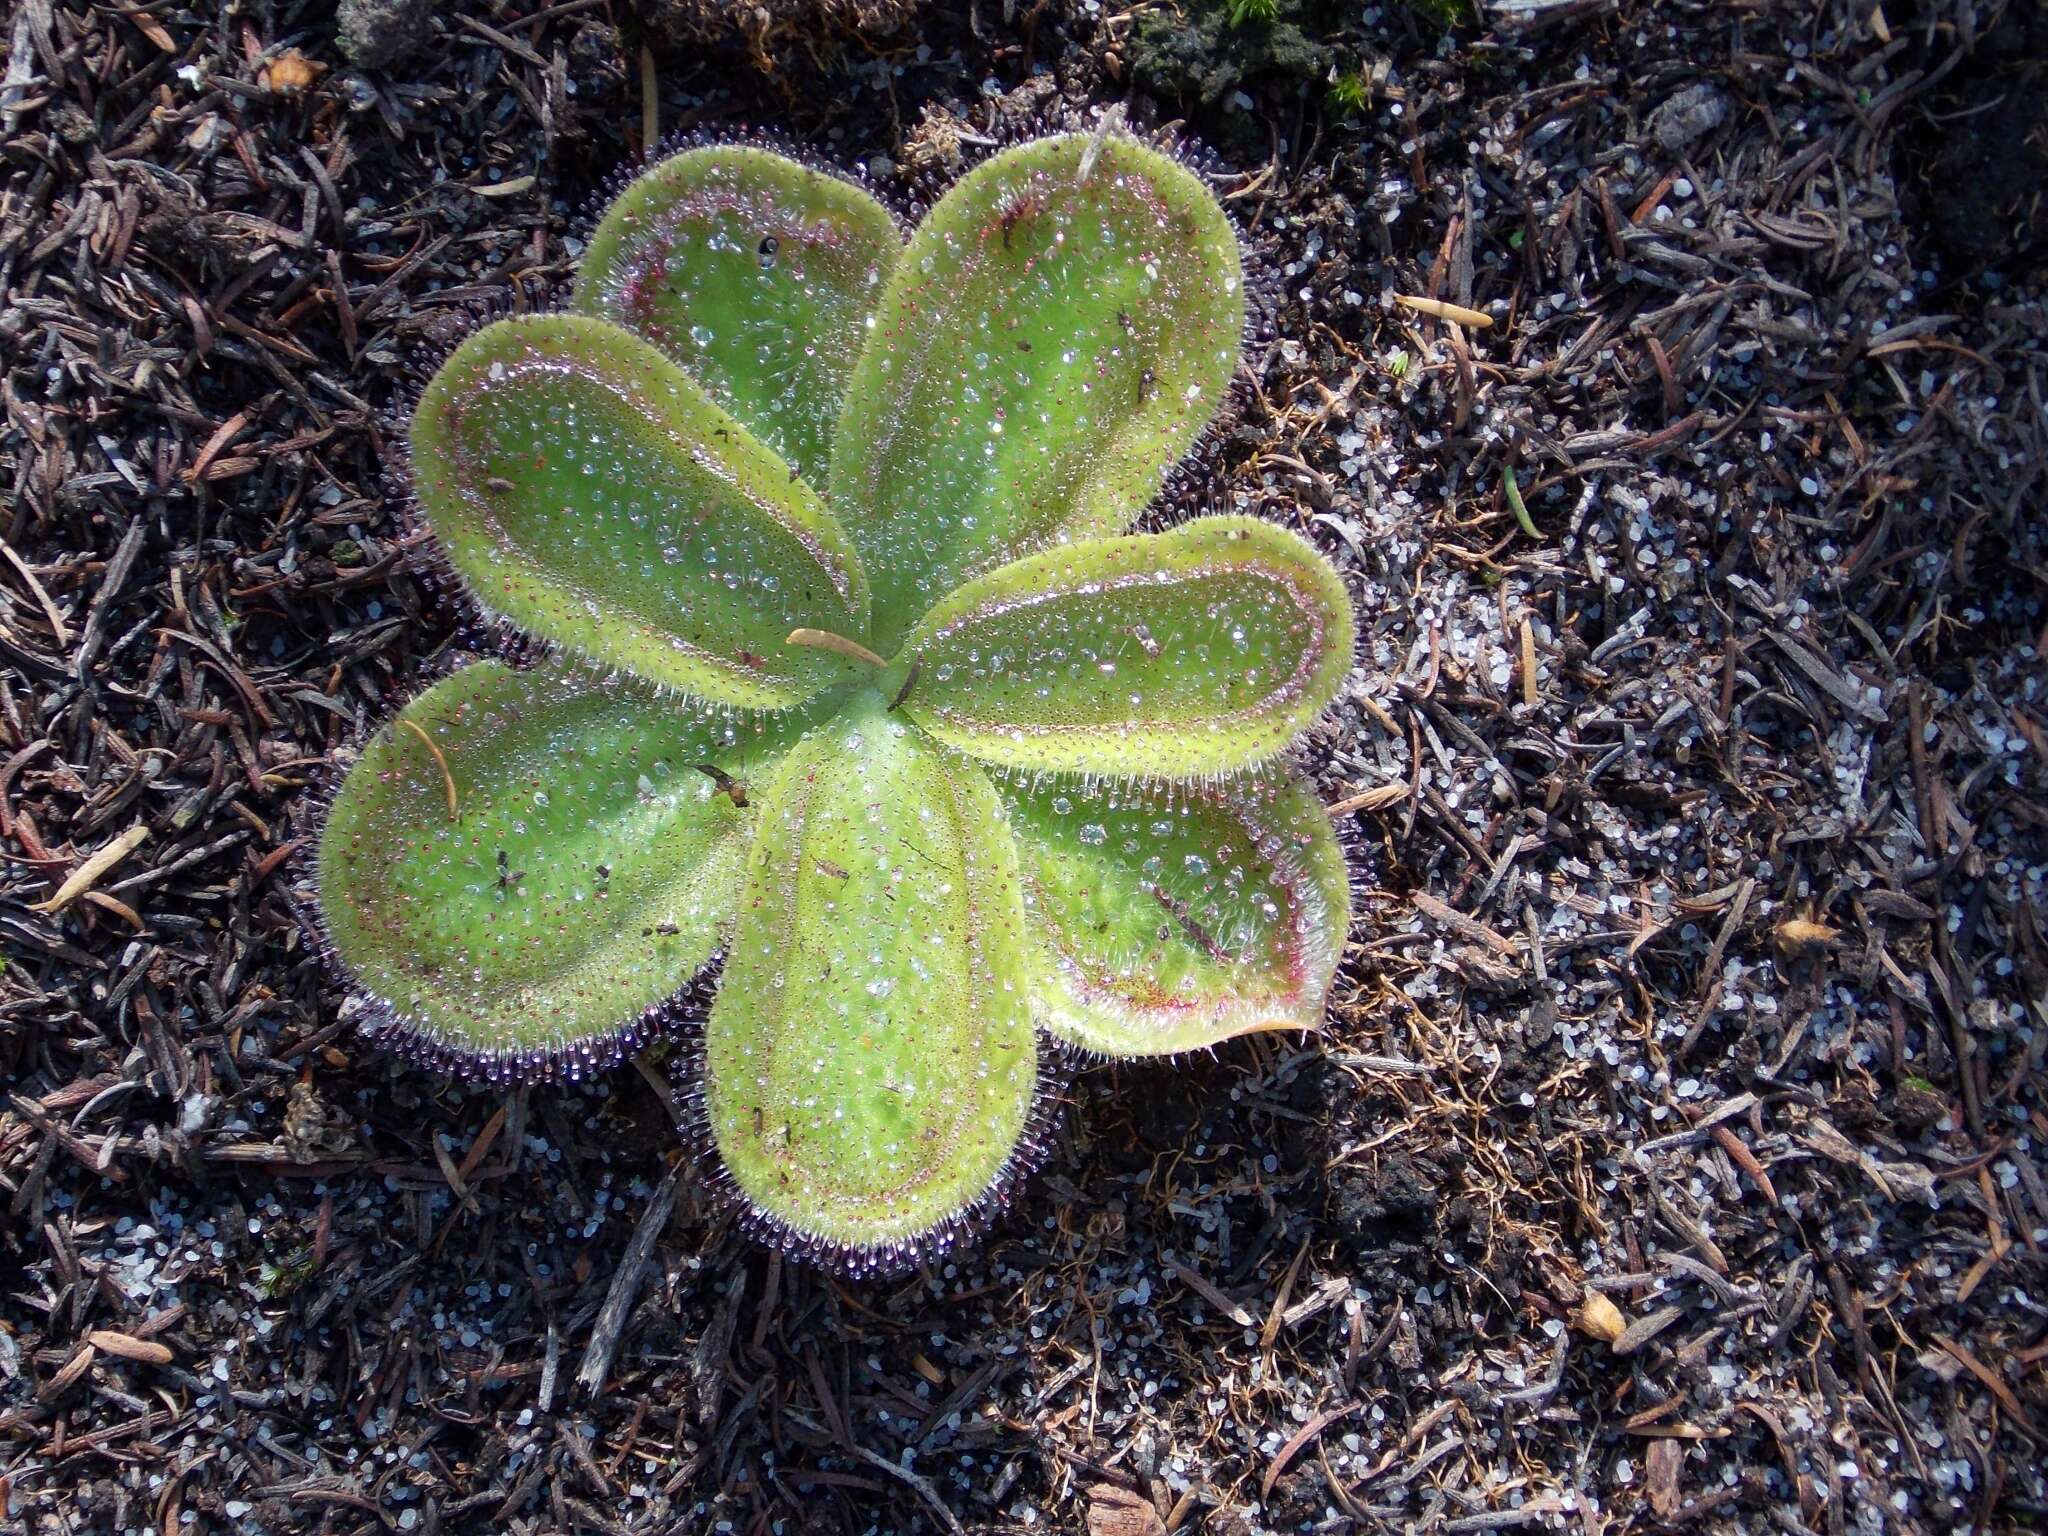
[705,694,1036,1257]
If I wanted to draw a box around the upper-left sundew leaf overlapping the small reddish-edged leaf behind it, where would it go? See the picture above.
[412,315,866,709]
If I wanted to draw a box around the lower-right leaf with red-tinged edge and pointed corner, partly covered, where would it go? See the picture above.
[1001,772,1350,1057]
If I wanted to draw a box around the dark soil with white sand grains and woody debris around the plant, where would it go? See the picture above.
[0,0,2048,1536]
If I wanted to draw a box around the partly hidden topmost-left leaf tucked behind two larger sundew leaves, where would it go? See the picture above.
[575,143,903,485]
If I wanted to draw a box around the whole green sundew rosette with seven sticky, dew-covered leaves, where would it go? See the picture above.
[315,131,1352,1272]
